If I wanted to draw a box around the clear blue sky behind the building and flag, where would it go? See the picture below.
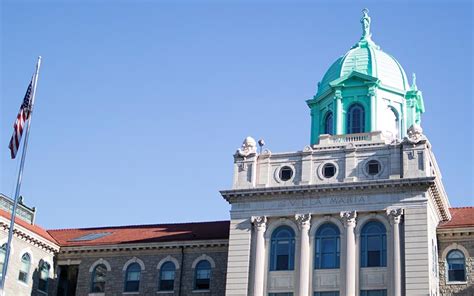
[0,1,474,228]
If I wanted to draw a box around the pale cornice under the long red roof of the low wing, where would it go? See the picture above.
[60,239,229,254]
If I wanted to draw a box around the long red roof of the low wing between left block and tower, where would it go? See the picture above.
[48,221,230,247]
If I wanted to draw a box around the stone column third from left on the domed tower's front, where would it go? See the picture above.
[341,211,357,296]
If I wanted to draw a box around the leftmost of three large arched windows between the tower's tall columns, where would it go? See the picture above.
[270,226,295,270]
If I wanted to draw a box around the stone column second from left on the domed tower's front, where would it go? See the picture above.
[295,214,311,296]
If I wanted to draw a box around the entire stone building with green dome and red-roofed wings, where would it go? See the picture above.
[0,11,474,296]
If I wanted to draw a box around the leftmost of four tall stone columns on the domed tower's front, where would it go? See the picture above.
[252,216,267,296]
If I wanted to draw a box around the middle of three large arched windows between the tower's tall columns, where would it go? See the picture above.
[315,223,340,269]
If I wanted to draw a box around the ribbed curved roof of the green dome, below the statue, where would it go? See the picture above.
[317,44,409,95]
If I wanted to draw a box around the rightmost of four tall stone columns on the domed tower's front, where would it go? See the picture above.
[387,209,403,296]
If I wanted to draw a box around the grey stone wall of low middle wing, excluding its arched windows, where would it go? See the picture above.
[51,241,227,296]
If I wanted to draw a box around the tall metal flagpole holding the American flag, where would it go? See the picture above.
[0,56,41,296]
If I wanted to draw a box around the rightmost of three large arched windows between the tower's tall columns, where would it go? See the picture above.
[360,221,387,267]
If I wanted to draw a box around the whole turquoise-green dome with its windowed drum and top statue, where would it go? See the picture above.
[307,9,424,144]
